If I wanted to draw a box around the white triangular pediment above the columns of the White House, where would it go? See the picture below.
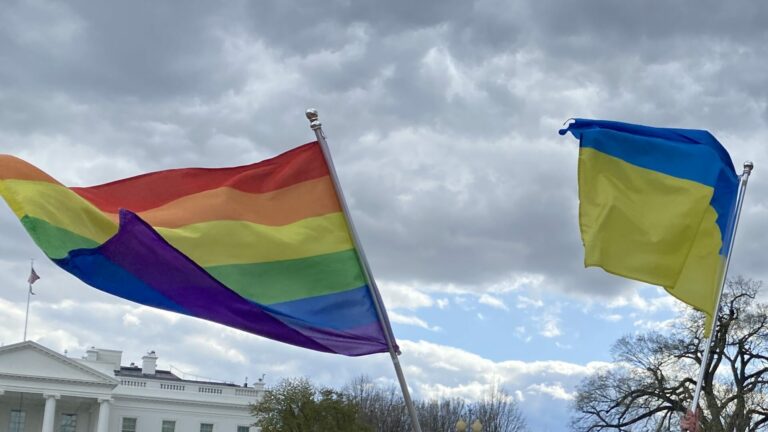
[0,341,118,387]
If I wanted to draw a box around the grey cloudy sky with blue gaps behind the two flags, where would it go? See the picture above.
[0,0,768,431]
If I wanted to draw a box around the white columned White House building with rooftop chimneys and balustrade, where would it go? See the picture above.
[0,341,264,432]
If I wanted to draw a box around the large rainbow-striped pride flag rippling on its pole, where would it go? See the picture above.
[0,142,388,356]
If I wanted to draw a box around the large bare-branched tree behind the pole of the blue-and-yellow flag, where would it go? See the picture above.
[571,278,768,432]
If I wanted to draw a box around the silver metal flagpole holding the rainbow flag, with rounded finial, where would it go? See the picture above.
[306,109,421,432]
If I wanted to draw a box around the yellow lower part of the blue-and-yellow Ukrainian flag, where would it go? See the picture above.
[579,148,724,330]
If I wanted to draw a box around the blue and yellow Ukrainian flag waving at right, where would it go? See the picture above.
[560,119,739,329]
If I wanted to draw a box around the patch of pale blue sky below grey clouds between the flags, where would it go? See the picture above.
[393,286,677,364]
